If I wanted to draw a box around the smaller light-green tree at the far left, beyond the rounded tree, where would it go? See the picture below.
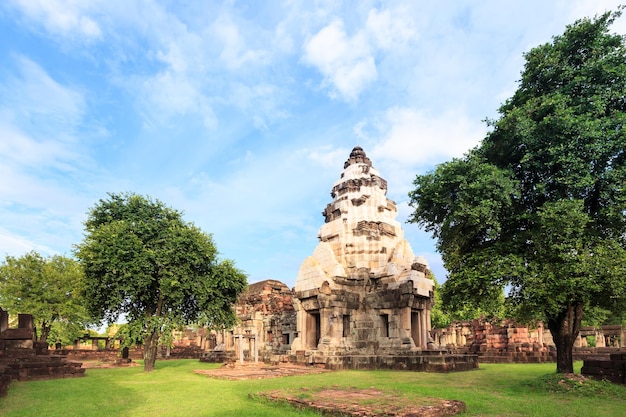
[0,251,90,343]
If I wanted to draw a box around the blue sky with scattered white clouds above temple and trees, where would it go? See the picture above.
[0,0,626,287]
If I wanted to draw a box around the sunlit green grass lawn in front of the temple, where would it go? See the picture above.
[0,360,626,417]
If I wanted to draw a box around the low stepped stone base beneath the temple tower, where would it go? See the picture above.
[292,350,478,372]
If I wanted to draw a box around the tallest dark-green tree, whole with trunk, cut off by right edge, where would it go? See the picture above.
[410,11,626,372]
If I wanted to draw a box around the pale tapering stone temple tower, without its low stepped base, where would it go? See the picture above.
[291,146,433,356]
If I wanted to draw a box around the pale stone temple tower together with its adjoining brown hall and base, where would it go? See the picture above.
[204,146,478,371]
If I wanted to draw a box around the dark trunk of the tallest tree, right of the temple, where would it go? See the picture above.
[548,303,583,374]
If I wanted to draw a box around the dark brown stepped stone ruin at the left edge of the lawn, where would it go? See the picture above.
[0,308,85,396]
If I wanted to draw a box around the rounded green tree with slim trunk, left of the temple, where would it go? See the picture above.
[76,193,246,371]
